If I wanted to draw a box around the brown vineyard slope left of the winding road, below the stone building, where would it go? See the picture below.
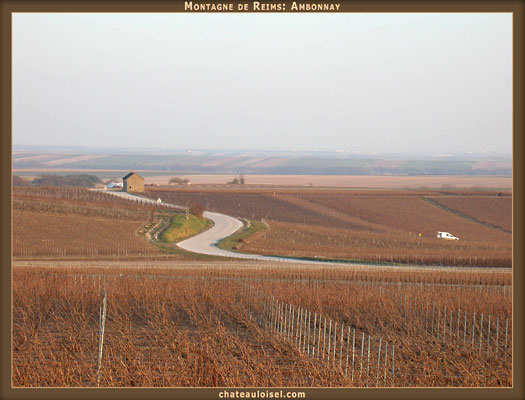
[13,187,173,258]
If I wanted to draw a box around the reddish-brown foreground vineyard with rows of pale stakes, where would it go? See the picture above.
[12,263,512,387]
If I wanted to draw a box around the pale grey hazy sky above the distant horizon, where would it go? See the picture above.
[13,13,512,153]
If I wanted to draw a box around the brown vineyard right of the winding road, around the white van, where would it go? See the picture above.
[146,188,512,267]
